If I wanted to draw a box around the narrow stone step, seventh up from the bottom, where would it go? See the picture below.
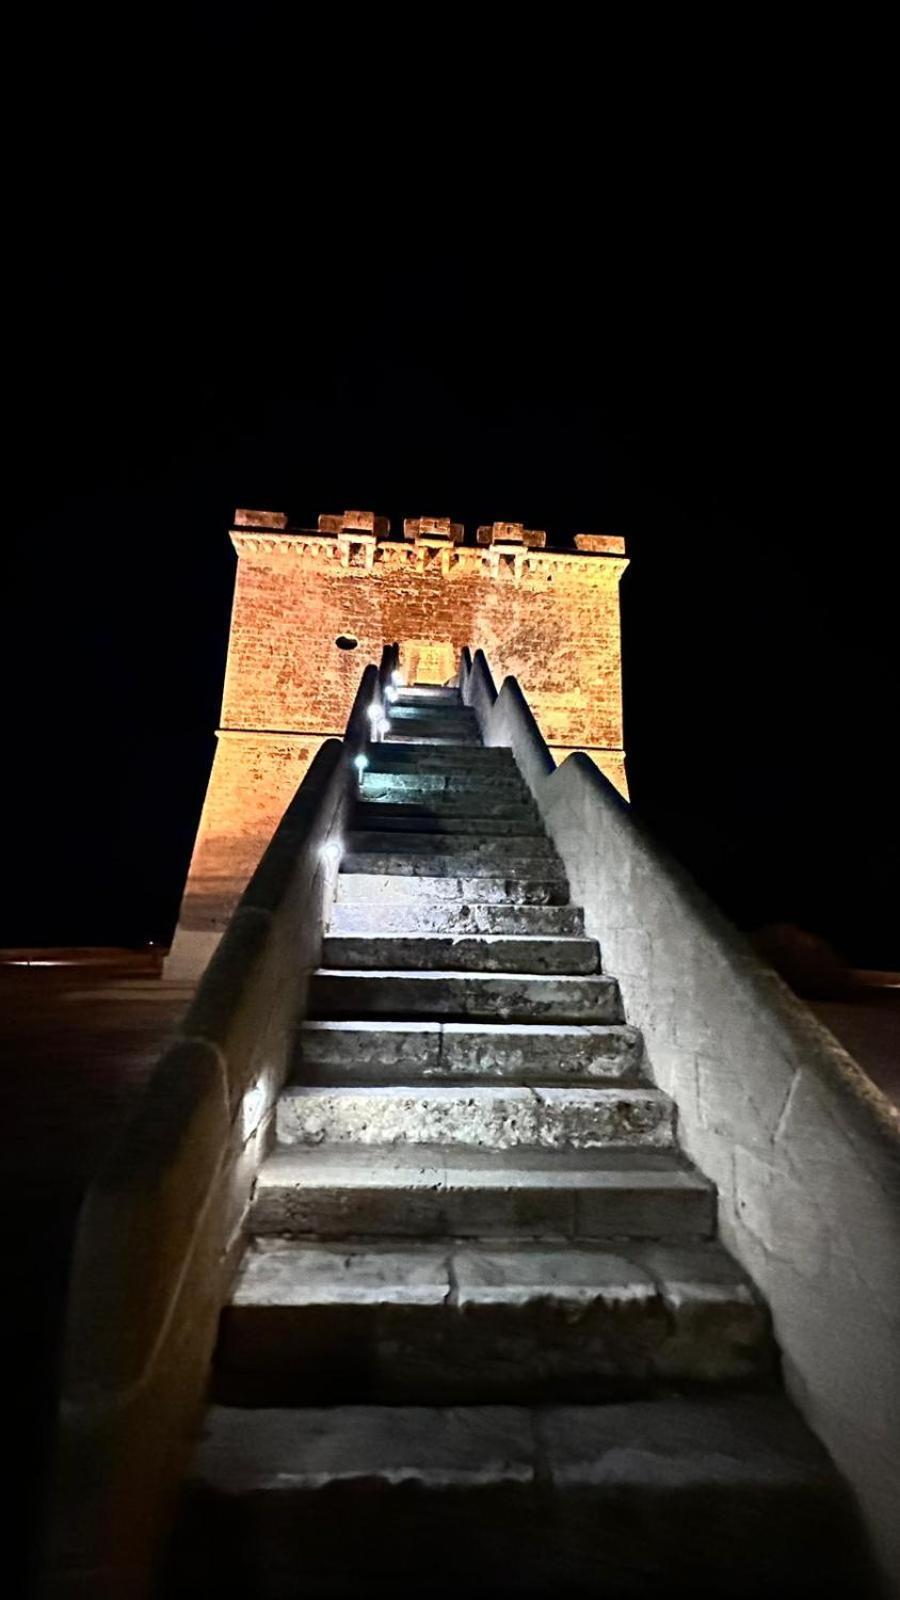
[322,933,601,973]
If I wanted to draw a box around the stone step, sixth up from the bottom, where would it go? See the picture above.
[309,966,614,1022]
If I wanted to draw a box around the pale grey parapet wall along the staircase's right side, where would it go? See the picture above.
[469,658,900,1594]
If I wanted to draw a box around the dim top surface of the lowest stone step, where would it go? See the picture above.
[184,1395,836,1494]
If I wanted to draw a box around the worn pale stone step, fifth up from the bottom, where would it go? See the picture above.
[293,1019,644,1085]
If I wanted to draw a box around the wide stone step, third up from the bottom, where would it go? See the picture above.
[250,1144,716,1238]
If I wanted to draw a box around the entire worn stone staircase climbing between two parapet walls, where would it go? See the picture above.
[167,688,858,1600]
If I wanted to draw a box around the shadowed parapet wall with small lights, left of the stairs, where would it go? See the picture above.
[43,741,349,1600]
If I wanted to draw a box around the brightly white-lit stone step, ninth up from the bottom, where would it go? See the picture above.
[335,856,569,906]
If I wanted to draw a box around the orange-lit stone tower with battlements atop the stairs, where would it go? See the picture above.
[173,510,628,955]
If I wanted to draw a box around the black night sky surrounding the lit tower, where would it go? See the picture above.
[7,6,900,966]
